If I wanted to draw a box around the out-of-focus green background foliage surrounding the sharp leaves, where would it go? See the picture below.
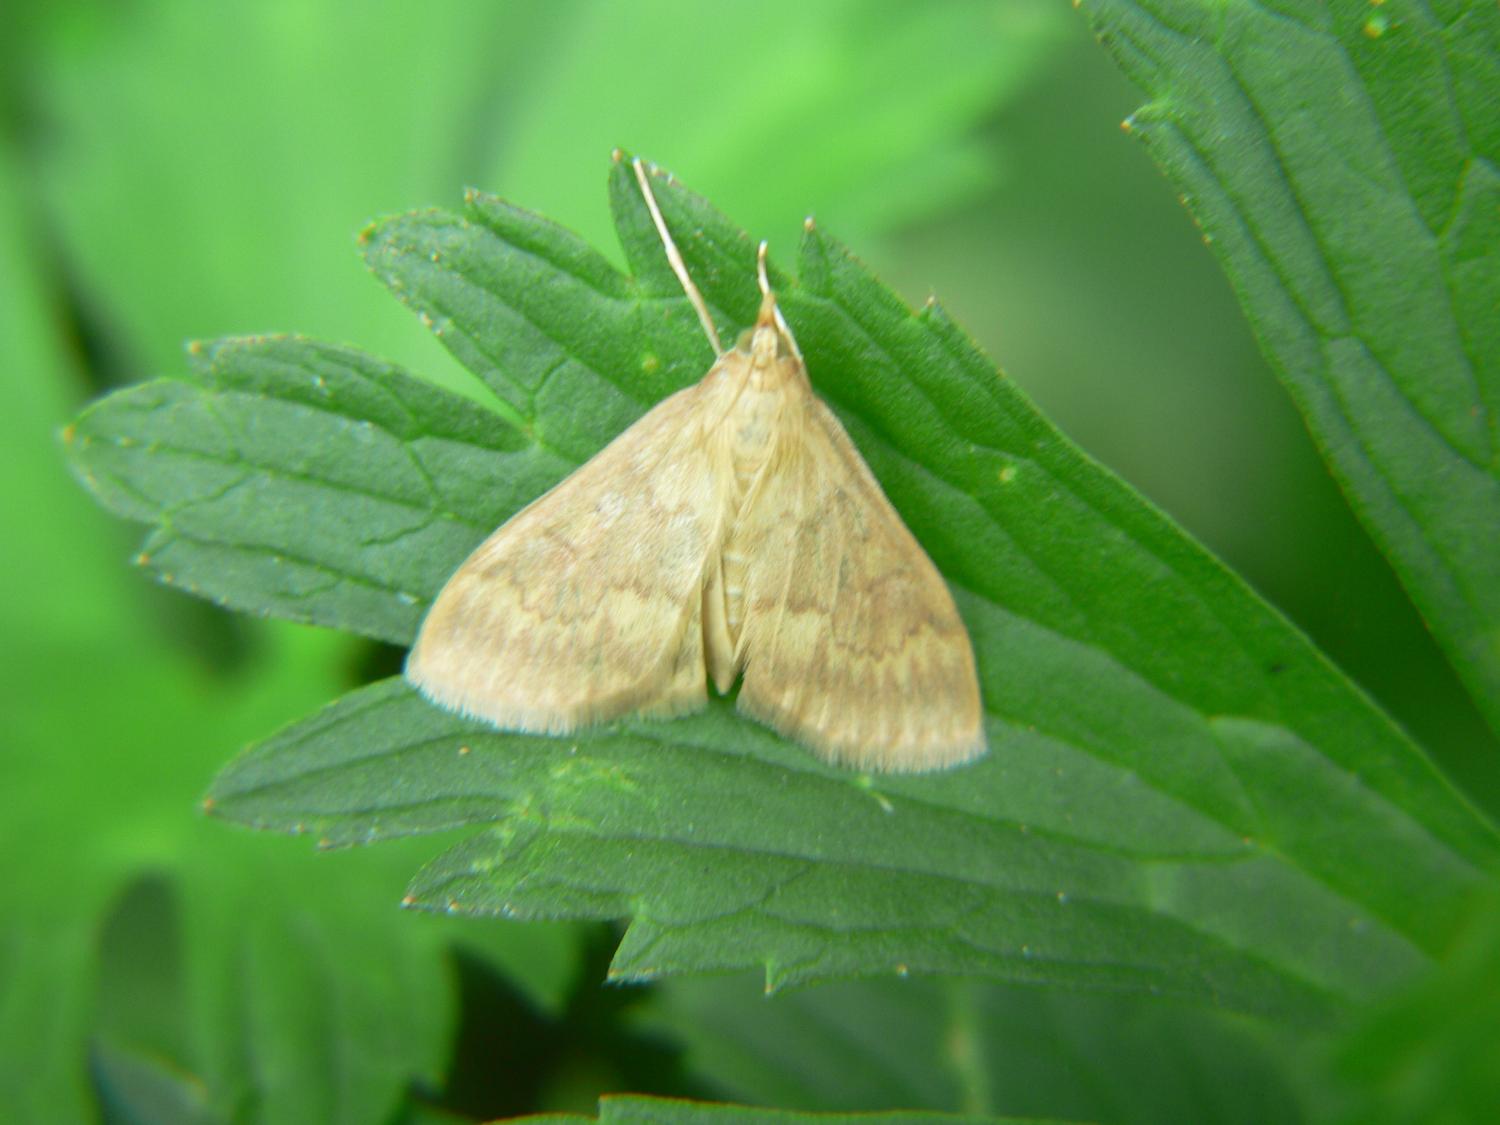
[0,0,1500,1122]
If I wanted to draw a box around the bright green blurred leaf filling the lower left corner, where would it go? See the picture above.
[0,146,572,1125]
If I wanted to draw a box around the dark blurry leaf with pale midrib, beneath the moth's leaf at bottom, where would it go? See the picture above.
[644,977,1307,1125]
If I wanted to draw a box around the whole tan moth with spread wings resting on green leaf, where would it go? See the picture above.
[407,159,986,771]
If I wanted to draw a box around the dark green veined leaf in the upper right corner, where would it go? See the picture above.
[1086,0,1500,741]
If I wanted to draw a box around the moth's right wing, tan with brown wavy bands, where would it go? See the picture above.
[726,392,984,771]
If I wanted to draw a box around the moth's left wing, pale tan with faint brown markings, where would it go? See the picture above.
[407,384,723,732]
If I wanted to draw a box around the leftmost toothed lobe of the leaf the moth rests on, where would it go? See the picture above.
[66,338,566,642]
